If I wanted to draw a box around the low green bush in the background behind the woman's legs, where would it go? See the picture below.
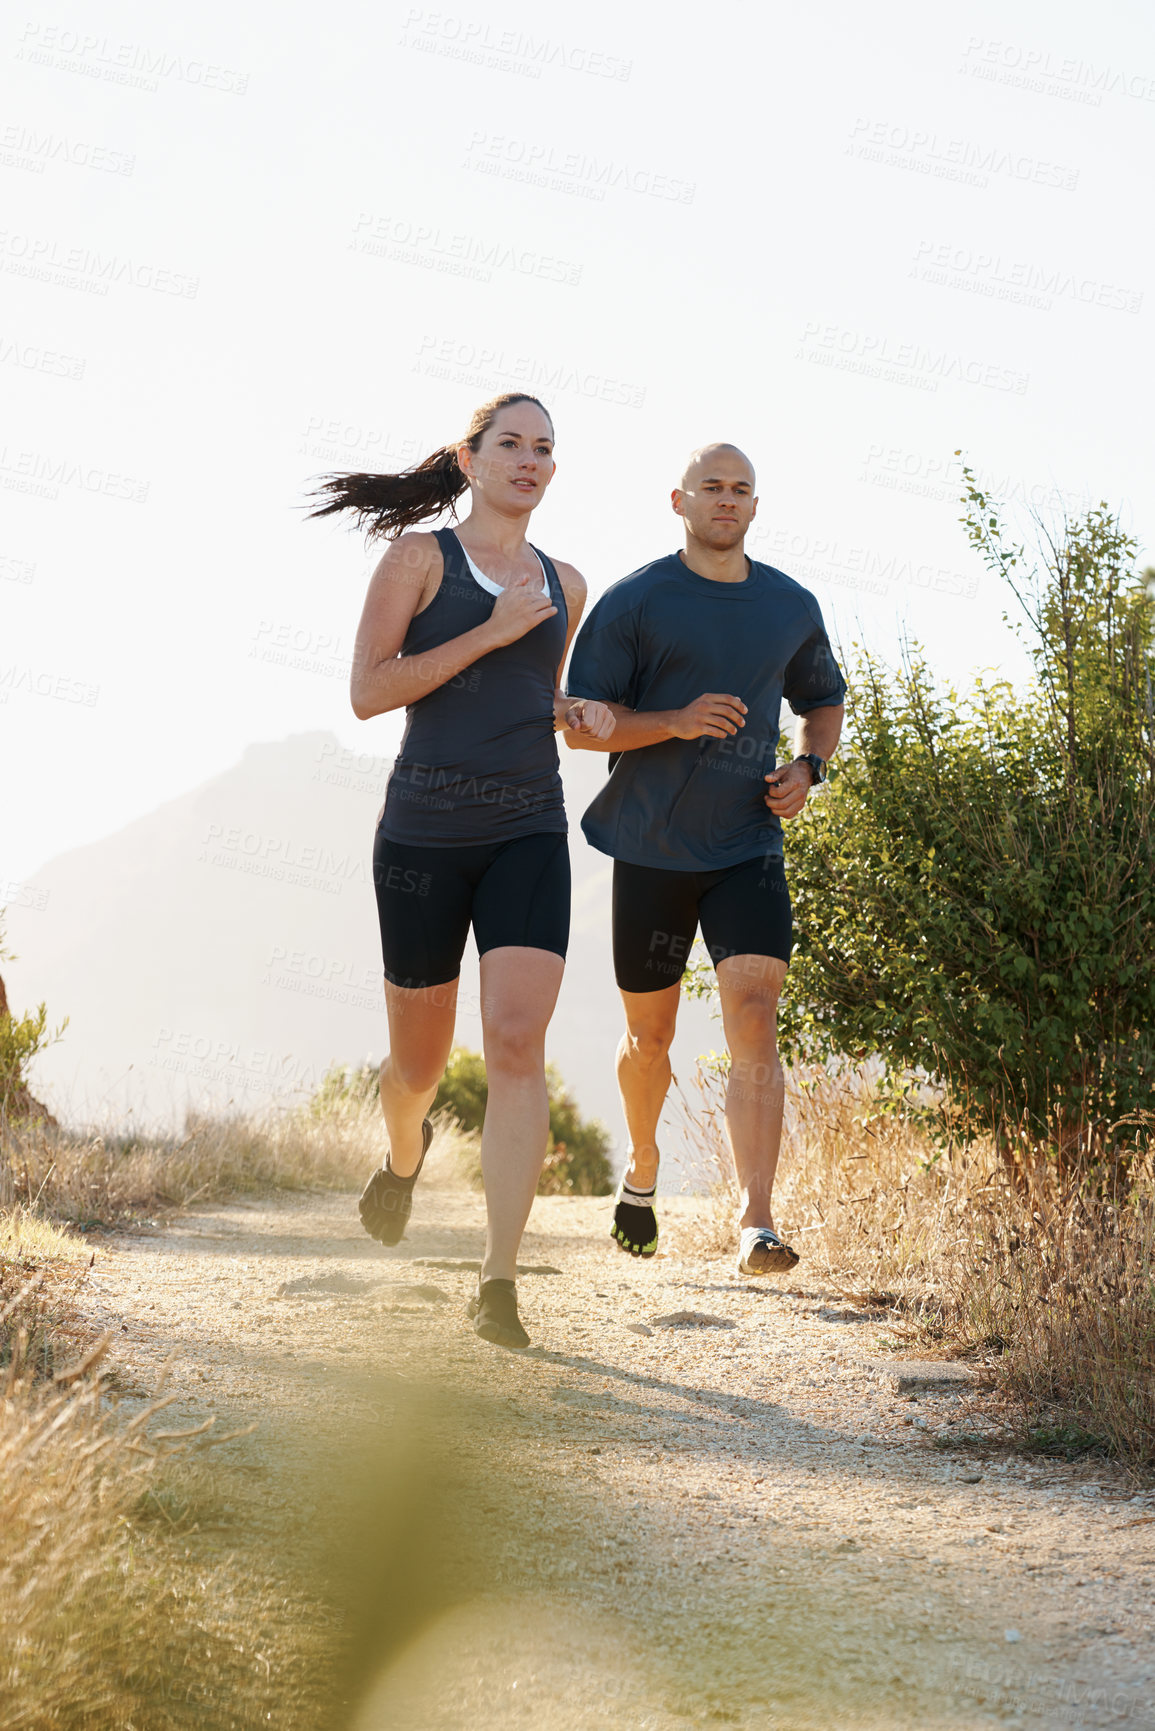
[310,1046,613,1196]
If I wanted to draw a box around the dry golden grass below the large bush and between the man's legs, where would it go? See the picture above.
[671,1061,1155,1475]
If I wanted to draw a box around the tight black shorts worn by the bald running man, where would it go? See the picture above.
[613,857,793,992]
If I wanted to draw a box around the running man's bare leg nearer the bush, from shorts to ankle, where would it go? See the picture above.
[717,956,786,1267]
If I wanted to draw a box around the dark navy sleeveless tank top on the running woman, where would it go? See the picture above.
[379,530,568,846]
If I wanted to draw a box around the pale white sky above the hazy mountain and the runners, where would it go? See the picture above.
[0,0,1155,902]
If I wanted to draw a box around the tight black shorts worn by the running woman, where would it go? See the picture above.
[372,831,570,987]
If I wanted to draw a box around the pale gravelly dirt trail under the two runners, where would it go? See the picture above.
[87,1184,1155,1731]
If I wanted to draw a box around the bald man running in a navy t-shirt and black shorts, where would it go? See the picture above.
[566,445,845,1274]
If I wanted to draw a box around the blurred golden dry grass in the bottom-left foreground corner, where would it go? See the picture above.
[0,1271,329,1731]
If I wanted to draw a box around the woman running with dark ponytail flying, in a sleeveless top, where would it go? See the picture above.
[313,393,613,1347]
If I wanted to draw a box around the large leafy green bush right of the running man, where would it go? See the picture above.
[692,471,1155,1177]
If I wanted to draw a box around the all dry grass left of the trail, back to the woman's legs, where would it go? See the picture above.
[0,1101,488,1731]
